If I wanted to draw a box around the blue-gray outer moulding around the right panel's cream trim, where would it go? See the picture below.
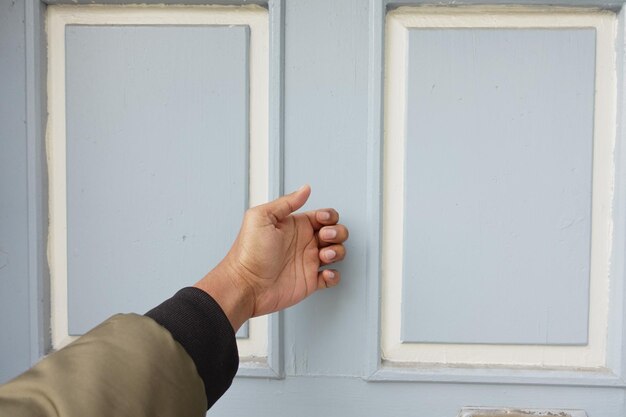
[363,0,626,392]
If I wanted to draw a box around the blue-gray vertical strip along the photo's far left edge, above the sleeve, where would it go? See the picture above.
[0,1,31,383]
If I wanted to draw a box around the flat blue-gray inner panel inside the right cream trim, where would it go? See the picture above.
[402,29,595,344]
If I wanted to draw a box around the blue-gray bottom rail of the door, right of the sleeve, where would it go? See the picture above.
[209,376,626,417]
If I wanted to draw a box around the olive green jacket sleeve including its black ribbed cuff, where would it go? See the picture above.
[0,289,238,417]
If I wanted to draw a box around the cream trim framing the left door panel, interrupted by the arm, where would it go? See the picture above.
[46,5,269,359]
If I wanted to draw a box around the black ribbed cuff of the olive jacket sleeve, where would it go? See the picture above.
[145,287,239,408]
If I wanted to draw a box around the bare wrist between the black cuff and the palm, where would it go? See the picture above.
[194,261,254,332]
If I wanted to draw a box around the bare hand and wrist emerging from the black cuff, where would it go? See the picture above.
[194,185,348,331]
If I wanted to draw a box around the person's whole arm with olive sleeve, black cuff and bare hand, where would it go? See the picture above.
[0,186,348,417]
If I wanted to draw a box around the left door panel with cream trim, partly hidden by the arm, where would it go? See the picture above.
[47,6,268,366]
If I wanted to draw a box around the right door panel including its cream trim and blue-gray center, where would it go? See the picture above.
[381,7,616,379]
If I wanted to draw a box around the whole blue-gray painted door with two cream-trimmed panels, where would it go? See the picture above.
[0,0,626,417]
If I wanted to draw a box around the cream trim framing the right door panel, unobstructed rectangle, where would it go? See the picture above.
[381,6,616,368]
